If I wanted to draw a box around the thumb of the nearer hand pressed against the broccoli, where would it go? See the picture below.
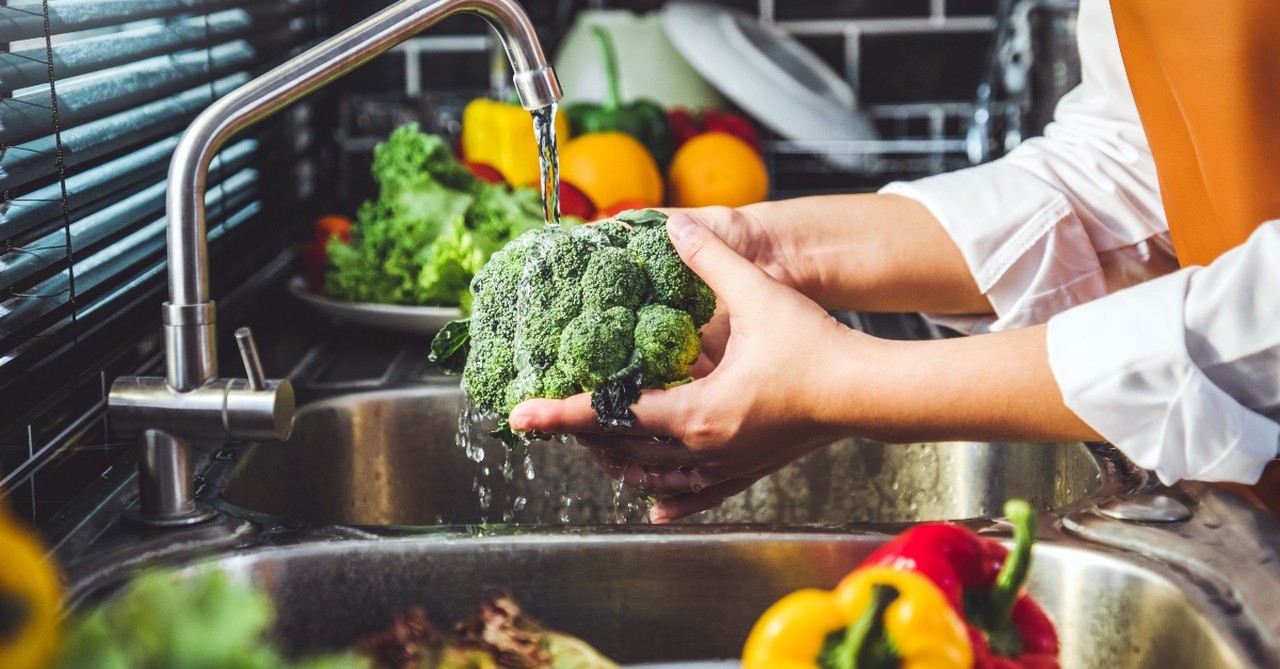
[667,214,776,312]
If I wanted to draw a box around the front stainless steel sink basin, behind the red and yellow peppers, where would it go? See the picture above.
[74,528,1274,669]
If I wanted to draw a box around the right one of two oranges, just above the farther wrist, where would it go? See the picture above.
[667,132,769,207]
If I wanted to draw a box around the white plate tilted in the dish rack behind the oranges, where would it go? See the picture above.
[662,0,877,139]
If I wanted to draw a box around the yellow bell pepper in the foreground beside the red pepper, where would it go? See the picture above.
[742,567,973,669]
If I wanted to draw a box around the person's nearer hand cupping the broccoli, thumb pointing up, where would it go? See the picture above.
[511,214,877,522]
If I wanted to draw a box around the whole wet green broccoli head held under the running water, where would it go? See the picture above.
[430,210,716,445]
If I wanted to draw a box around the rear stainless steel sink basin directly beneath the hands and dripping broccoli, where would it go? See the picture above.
[223,384,1107,524]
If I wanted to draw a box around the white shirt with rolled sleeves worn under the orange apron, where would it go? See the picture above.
[882,0,1280,484]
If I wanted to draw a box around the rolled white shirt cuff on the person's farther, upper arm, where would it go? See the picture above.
[881,161,1107,333]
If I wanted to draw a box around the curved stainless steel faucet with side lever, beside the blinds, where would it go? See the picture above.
[108,0,561,527]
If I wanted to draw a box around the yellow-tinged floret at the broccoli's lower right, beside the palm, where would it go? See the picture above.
[635,304,701,388]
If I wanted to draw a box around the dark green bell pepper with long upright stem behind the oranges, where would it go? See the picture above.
[564,26,673,169]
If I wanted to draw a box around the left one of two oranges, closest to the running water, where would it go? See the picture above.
[559,132,663,209]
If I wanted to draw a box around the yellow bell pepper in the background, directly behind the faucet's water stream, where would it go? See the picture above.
[462,97,570,185]
